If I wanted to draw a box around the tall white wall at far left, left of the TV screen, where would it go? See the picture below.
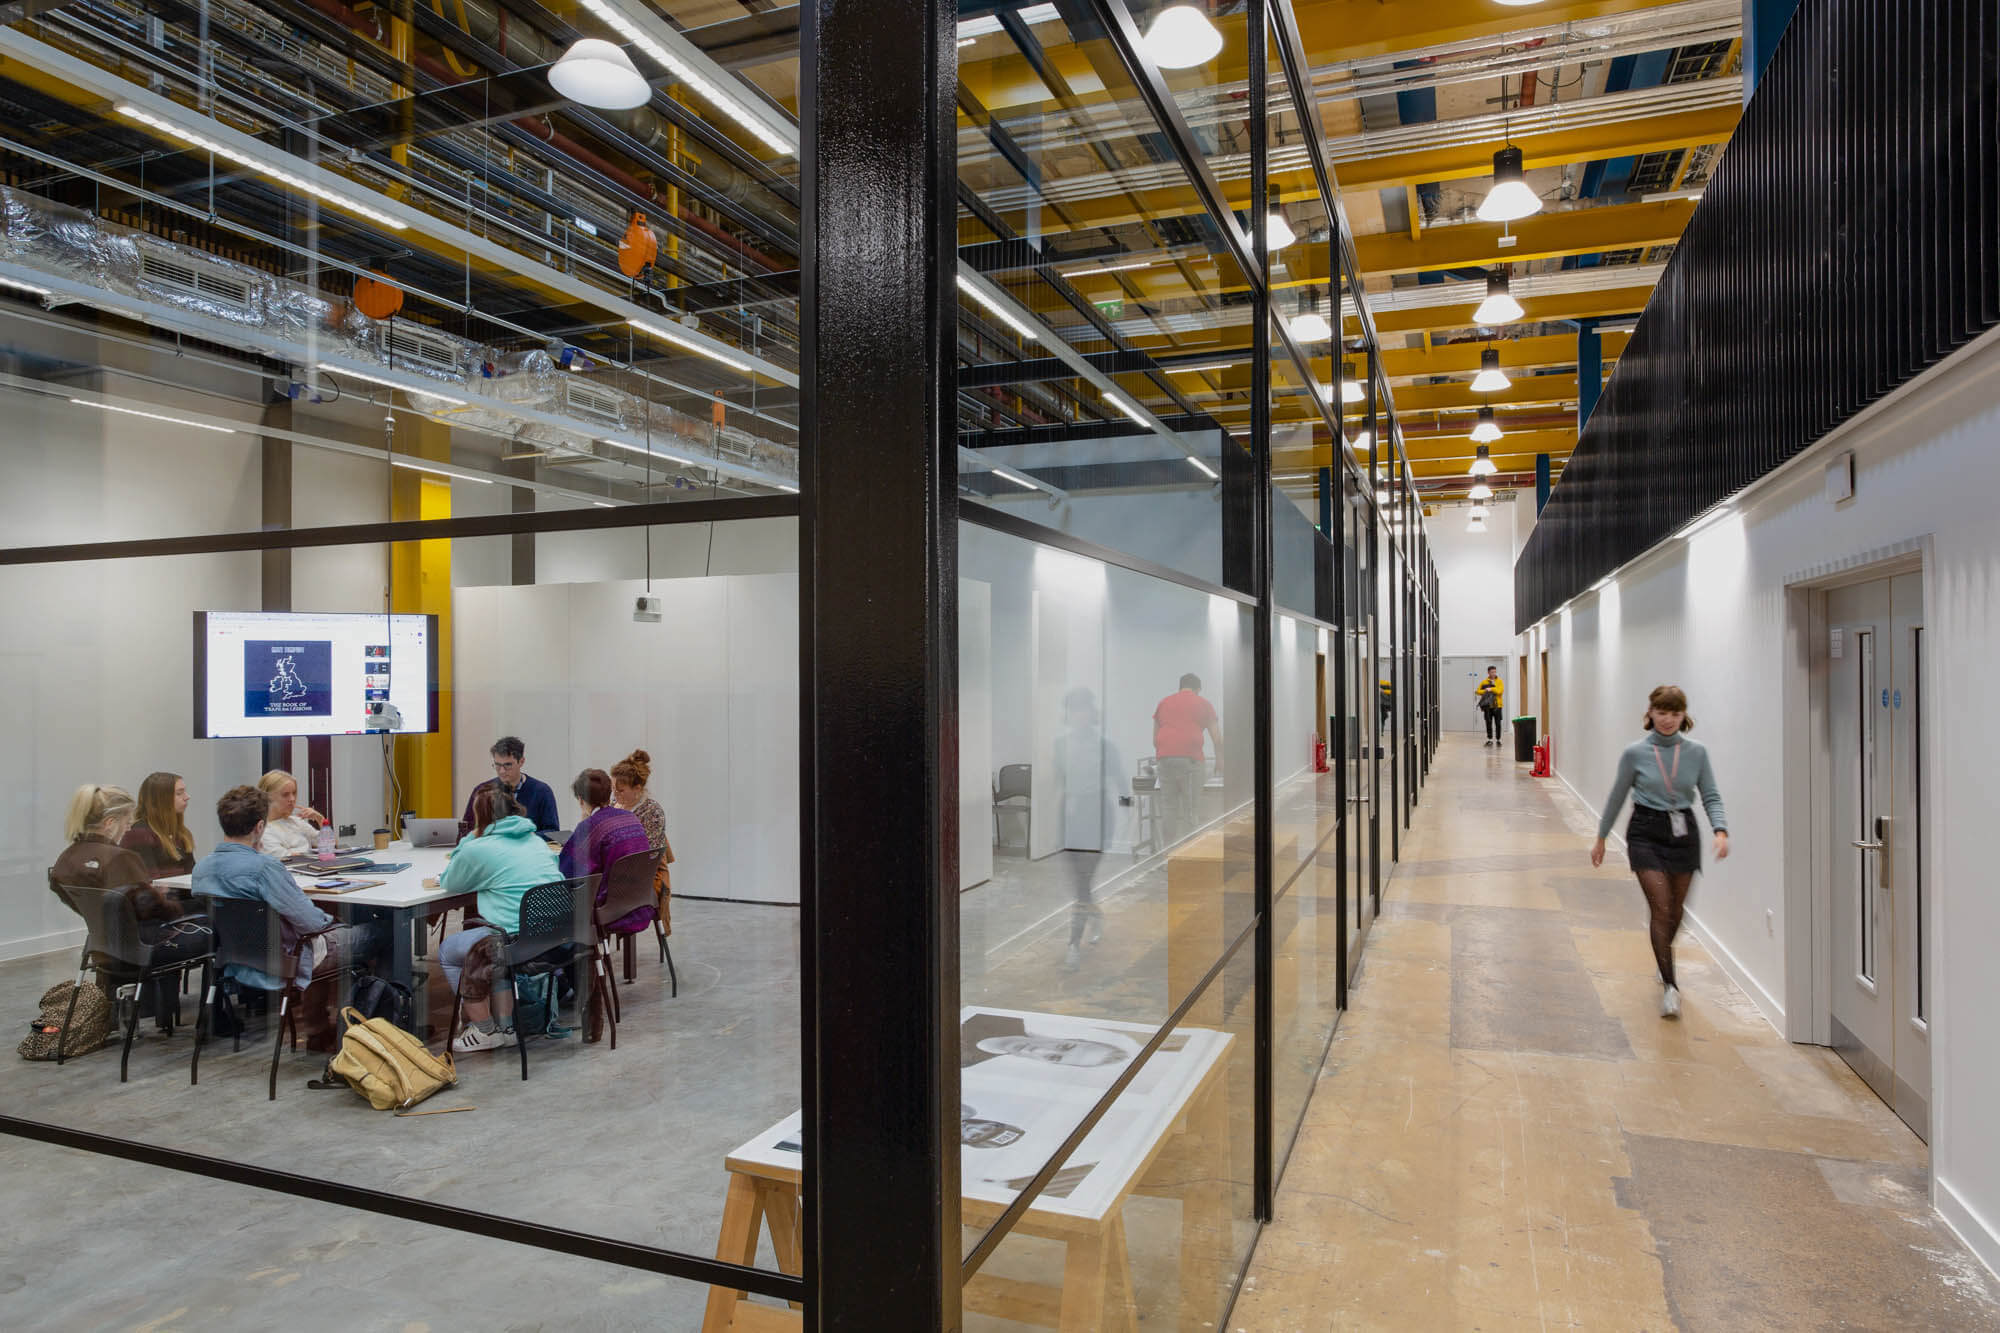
[0,376,262,959]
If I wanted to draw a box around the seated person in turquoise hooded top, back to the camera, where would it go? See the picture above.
[438,787,564,1055]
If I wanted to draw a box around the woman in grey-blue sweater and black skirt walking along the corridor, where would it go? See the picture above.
[1590,685,1730,1019]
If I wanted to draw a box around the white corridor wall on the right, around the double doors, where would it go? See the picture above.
[1526,326,2000,1267]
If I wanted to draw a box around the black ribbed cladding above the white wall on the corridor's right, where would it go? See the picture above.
[1514,0,2000,628]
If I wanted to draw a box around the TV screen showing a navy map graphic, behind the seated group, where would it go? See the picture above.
[194,610,438,739]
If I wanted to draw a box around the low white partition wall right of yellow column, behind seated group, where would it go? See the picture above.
[454,574,798,903]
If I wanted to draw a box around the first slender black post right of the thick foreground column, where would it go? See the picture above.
[1244,0,1272,1221]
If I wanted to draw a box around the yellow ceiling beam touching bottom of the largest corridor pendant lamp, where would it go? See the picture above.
[1354,198,1694,274]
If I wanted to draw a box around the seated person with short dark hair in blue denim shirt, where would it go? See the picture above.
[194,787,386,1051]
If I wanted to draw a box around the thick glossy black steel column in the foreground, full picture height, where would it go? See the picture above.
[800,0,960,1333]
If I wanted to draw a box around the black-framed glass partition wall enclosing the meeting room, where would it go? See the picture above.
[0,0,1436,1329]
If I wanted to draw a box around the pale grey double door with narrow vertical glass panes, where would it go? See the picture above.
[1824,574,1930,1141]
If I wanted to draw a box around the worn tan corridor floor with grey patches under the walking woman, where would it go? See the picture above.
[1230,735,2000,1333]
